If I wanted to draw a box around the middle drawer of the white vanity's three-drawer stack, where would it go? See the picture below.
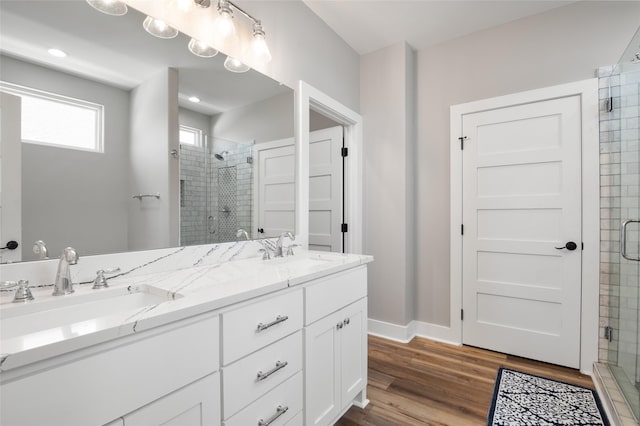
[222,331,302,418]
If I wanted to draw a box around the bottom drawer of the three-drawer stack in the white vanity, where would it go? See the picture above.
[224,372,302,426]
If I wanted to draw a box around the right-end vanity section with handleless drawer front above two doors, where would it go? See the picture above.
[305,268,367,426]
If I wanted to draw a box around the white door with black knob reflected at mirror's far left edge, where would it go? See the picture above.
[0,93,22,263]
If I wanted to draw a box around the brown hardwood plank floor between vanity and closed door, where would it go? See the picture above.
[336,336,593,426]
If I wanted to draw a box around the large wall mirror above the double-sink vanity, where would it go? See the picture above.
[0,0,296,262]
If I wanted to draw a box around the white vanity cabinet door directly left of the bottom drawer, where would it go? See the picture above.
[124,373,220,426]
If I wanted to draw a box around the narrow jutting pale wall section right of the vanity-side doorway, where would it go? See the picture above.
[360,43,415,324]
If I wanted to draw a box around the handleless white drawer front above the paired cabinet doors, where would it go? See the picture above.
[304,266,367,325]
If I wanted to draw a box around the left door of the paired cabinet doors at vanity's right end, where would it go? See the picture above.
[305,312,342,426]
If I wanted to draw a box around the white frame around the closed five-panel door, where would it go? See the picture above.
[449,78,600,374]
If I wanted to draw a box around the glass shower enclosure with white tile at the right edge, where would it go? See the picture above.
[599,25,640,419]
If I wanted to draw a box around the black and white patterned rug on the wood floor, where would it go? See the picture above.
[487,368,609,426]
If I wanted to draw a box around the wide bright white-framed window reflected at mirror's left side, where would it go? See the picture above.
[0,82,104,152]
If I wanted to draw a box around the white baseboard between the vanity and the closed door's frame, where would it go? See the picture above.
[368,318,462,346]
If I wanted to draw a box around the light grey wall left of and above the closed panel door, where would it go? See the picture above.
[416,1,640,325]
